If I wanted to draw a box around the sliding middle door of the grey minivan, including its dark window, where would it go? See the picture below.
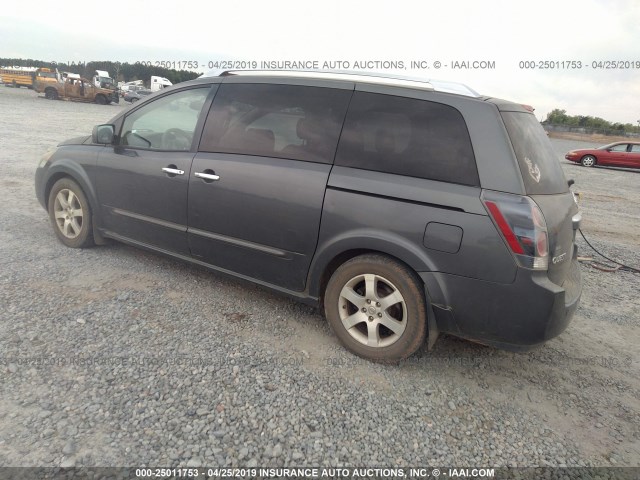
[188,83,351,291]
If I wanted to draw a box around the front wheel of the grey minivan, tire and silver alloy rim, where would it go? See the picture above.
[48,178,95,248]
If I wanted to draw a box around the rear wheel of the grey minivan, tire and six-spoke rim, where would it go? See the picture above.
[324,254,427,362]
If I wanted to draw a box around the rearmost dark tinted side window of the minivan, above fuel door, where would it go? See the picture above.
[336,92,480,186]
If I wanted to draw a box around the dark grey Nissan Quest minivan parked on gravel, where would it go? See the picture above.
[35,71,582,361]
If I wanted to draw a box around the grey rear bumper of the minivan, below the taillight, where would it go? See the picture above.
[420,255,582,351]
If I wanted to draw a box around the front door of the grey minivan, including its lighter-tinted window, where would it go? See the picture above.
[96,86,210,255]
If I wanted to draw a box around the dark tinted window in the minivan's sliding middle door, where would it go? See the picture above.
[200,84,352,163]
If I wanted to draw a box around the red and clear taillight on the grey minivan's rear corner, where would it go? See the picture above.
[481,190,549,270]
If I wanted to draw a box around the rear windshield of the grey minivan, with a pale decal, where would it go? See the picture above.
[501,112,569,195]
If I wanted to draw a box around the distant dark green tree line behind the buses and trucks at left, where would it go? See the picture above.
[0,58,200,85]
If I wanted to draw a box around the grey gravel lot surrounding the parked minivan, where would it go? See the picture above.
[0,87,640,467]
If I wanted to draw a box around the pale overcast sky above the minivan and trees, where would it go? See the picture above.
[0,0,640,125]
